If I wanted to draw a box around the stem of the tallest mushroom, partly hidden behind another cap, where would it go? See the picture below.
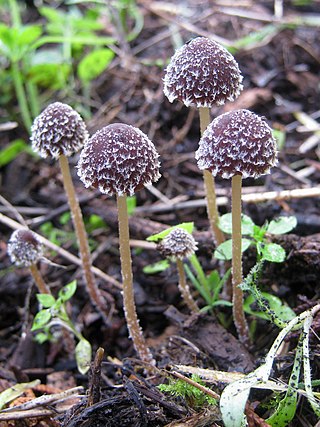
[199,107,225,246]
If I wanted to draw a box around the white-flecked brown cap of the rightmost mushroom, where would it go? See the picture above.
[196,110,277,178]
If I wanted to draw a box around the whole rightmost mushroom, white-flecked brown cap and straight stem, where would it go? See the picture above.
[196,110,277,344]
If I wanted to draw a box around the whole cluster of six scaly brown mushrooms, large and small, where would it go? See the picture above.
[8,37,276,365]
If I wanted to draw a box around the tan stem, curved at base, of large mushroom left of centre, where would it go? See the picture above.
[117,195,155,365]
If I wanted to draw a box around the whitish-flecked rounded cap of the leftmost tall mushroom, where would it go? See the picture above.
[30,102,89,159]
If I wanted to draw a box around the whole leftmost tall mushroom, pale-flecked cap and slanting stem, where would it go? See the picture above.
[31,102,107,321]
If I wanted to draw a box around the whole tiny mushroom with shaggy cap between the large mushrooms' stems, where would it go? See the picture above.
[158,228,199,312]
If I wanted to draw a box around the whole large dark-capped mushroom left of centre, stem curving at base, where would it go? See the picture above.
[78,123,160,364]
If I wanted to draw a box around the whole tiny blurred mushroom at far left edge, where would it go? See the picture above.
[7,228,50,294]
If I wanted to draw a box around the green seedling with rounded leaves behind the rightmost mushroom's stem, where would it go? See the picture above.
[214,214,297,262]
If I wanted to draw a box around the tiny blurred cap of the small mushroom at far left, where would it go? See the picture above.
[7,228,43,267]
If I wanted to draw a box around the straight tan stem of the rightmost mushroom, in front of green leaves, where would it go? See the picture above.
[232,175,249,346]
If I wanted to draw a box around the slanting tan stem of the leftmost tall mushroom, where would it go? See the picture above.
[59,154,107,322]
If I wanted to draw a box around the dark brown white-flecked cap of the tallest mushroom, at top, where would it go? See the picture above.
[163,37,243,107]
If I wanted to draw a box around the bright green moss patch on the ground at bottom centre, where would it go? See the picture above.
[158,374,217,410]
